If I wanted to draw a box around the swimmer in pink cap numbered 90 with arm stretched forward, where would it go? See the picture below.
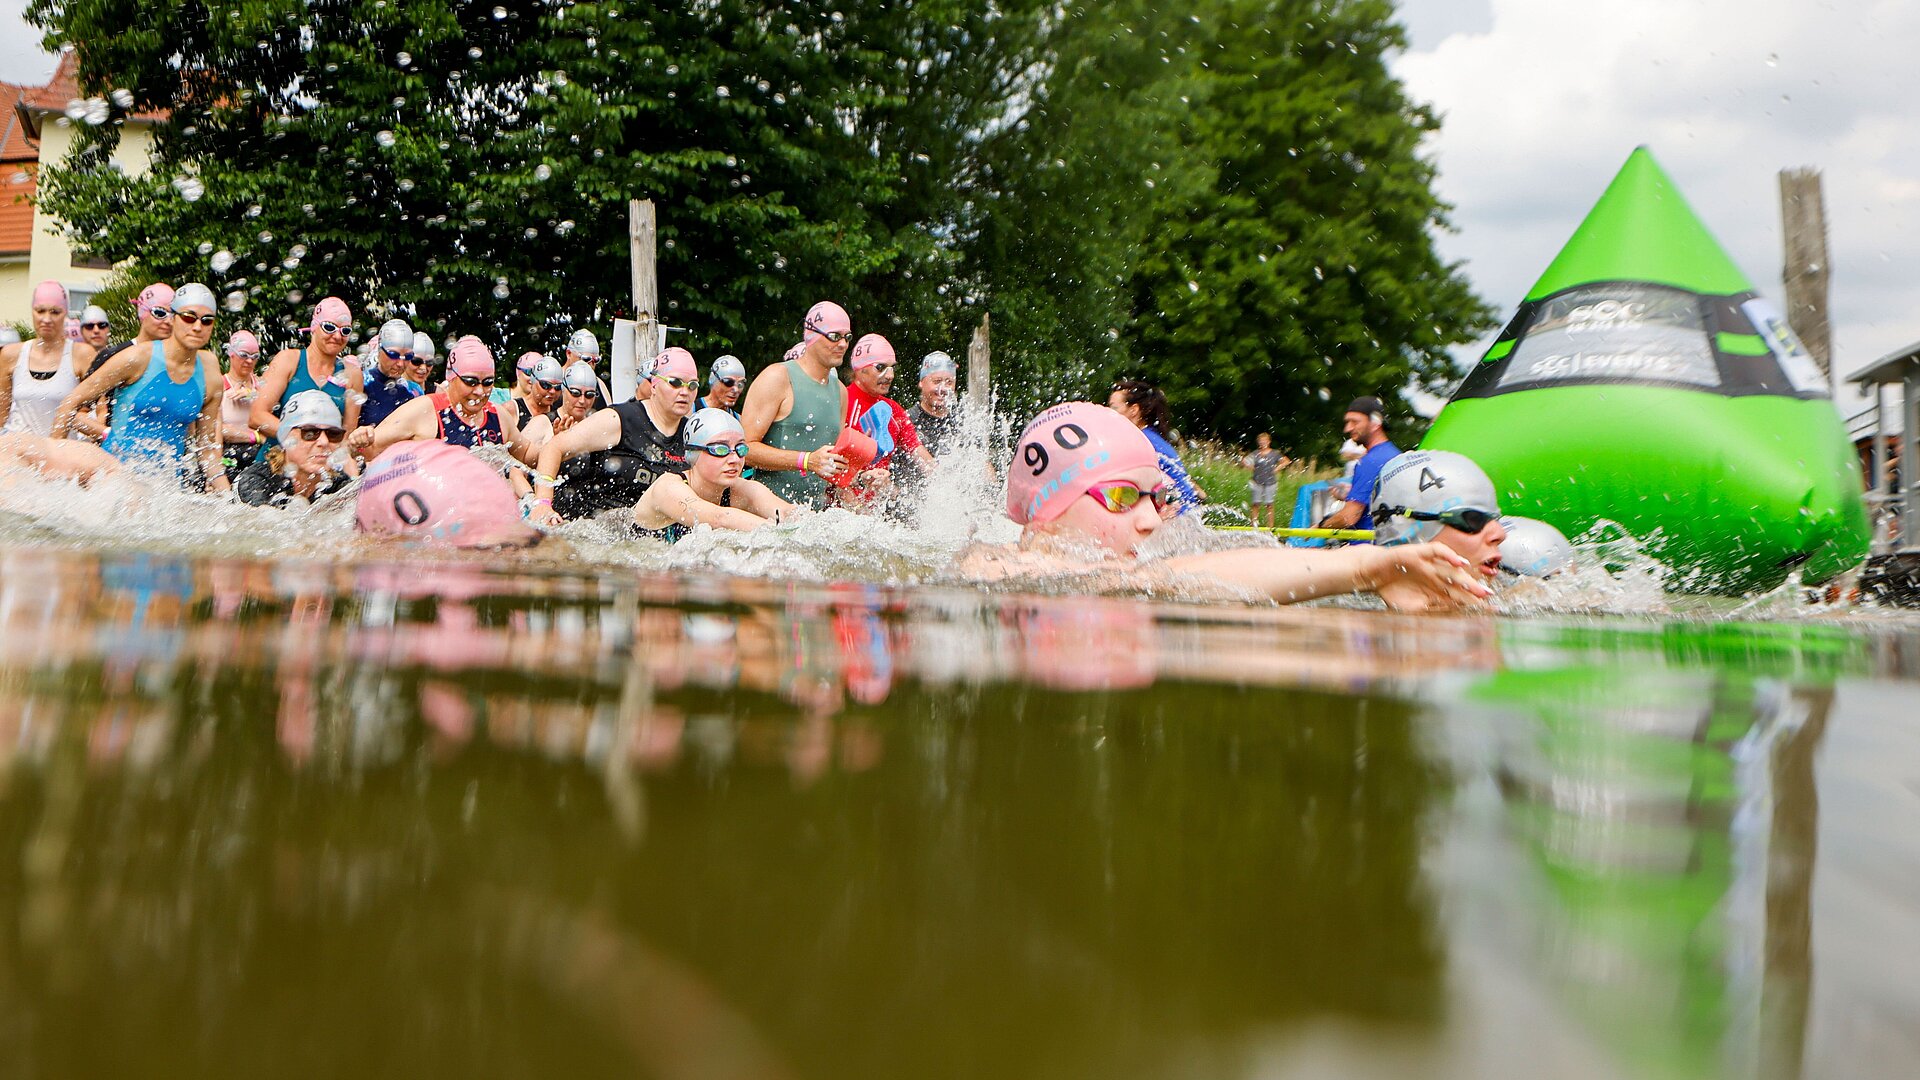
[960,402,1490,611]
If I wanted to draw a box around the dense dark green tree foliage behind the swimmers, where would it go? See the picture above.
[29,0,1488,448]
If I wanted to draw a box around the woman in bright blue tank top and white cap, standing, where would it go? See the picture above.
[52,281,232,492]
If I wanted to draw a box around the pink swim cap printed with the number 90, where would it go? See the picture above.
[1006,402,1160,525]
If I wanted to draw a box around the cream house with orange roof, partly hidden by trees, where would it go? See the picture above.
[0,52,165,323]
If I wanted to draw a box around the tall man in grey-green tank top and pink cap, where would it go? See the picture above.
[739,300,852,509]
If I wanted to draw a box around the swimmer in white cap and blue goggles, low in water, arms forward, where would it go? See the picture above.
[634,409,797,544]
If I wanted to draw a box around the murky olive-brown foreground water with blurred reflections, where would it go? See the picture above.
[0,550,1920,1076]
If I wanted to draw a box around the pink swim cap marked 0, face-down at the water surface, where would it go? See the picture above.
[353,442,540,548]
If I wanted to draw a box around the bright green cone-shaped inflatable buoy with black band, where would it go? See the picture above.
[1421,146,1868,592]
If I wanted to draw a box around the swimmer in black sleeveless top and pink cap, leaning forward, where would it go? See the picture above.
[528,346,699,527]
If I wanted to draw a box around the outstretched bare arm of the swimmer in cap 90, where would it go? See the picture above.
[1162,544,1490,611]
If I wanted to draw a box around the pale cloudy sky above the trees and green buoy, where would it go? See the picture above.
[0,0,1920,399]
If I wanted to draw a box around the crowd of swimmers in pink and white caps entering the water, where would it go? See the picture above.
[0,282,1574,609]
